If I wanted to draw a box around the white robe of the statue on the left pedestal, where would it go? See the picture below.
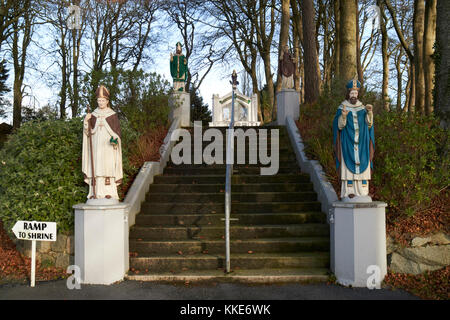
[82,108,123,199]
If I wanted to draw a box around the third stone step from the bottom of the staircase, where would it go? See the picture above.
[130,237,330,257]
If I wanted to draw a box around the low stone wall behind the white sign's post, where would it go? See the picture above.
[16,234,75,269]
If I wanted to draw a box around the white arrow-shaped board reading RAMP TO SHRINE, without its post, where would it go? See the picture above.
[12,221,56,241]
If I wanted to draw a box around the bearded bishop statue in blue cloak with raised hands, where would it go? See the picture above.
[333,77,375,202]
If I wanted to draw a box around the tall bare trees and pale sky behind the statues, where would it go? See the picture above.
[0,0,450,128]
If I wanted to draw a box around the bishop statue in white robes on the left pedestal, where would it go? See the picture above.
[82,85,123,201]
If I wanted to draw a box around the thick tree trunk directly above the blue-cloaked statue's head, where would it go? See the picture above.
[340,1,358,81]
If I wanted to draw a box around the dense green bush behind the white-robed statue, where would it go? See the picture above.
[0,118,138,232]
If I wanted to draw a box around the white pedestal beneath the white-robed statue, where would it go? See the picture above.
[73,203,129,285]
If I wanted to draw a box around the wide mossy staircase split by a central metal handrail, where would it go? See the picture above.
[127,127,329,282]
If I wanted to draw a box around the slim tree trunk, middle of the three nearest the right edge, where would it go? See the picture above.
[423,0,437,115]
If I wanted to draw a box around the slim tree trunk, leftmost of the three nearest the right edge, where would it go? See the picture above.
[413,0,425,114]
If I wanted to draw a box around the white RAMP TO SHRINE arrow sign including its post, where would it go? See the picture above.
[12,221,56,287]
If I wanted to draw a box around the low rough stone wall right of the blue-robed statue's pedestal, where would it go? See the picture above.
[386,233,450,274]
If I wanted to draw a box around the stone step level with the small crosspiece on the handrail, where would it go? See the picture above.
[136,212,327,227]
